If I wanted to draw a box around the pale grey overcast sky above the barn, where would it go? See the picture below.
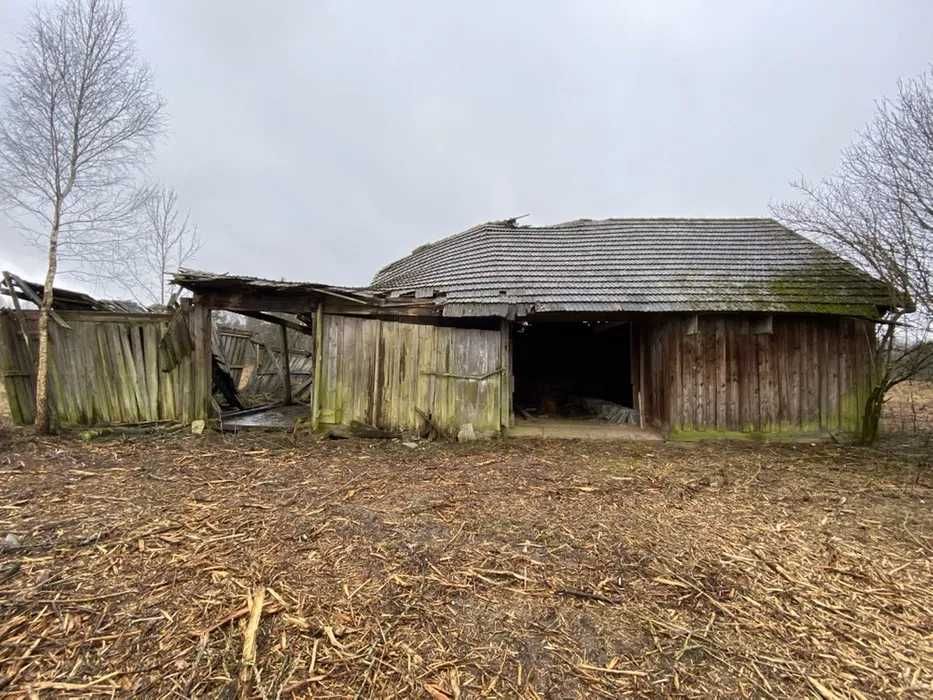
[0,0,933,288]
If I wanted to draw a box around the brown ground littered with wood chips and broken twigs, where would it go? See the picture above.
[0,424,933,700]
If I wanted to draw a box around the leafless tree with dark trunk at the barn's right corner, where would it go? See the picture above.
[774,70,933,443]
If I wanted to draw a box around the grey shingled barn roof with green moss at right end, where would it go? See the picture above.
[372,219,891,316]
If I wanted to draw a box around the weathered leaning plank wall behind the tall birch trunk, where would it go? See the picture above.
[0,311,209,426]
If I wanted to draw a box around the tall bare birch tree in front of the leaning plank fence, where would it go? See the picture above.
[0,0,163,432]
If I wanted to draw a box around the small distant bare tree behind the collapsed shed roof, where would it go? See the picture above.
[120,187,201,306]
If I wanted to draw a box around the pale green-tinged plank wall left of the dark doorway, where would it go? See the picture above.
[315,313,509,435]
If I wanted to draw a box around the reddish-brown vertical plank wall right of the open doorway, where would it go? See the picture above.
[642,315,874,435]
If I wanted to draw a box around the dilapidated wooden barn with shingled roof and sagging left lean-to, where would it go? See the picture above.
[176,219,891,437]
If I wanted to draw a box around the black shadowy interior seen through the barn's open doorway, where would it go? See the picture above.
[513,321,633,417]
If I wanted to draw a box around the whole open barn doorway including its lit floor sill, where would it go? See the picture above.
[512,321,652,436]
